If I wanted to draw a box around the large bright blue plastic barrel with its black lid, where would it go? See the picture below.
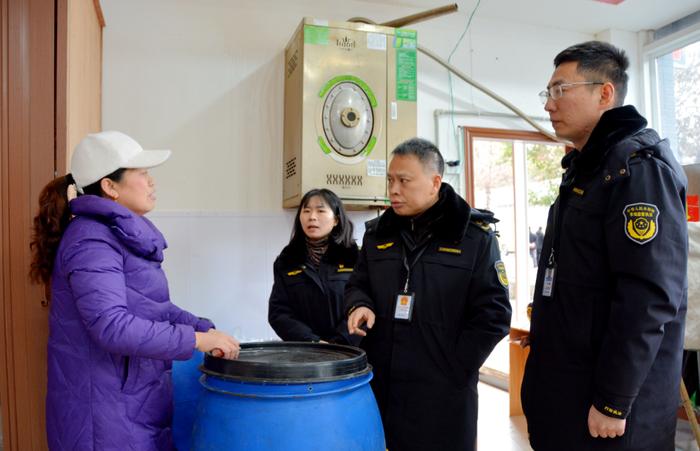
[192,342,385,451]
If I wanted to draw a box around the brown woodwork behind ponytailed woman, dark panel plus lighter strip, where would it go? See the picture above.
[0,0,104,451]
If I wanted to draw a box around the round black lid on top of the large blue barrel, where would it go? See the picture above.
[201,341,371,383]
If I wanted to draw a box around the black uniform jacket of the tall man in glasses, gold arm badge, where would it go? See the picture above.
[522,106,688,451]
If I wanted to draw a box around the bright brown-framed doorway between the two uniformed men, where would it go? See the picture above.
[463,127,565,388]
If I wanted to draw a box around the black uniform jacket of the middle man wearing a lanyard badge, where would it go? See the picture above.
[345,183,511,451]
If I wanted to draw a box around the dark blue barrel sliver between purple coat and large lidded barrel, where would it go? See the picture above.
[172,350,204,451]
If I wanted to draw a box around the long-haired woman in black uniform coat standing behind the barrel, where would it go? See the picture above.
[268,189,359,345]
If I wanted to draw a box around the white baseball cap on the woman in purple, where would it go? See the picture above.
[70,131,171,193]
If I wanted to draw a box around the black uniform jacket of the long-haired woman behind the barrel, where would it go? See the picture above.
[268,240,359,345]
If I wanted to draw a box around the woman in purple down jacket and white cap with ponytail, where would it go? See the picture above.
[31,132,239,450]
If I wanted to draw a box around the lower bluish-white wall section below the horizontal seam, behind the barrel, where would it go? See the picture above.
[149,210,376,341]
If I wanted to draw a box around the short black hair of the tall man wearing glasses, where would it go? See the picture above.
[554,41,630,106]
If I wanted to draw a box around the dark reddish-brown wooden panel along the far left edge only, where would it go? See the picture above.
[0,0,57,450]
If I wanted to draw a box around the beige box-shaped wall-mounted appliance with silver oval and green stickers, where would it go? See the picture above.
[282,18,417,208]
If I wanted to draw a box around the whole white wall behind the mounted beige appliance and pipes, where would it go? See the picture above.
[102,0,628,340]
